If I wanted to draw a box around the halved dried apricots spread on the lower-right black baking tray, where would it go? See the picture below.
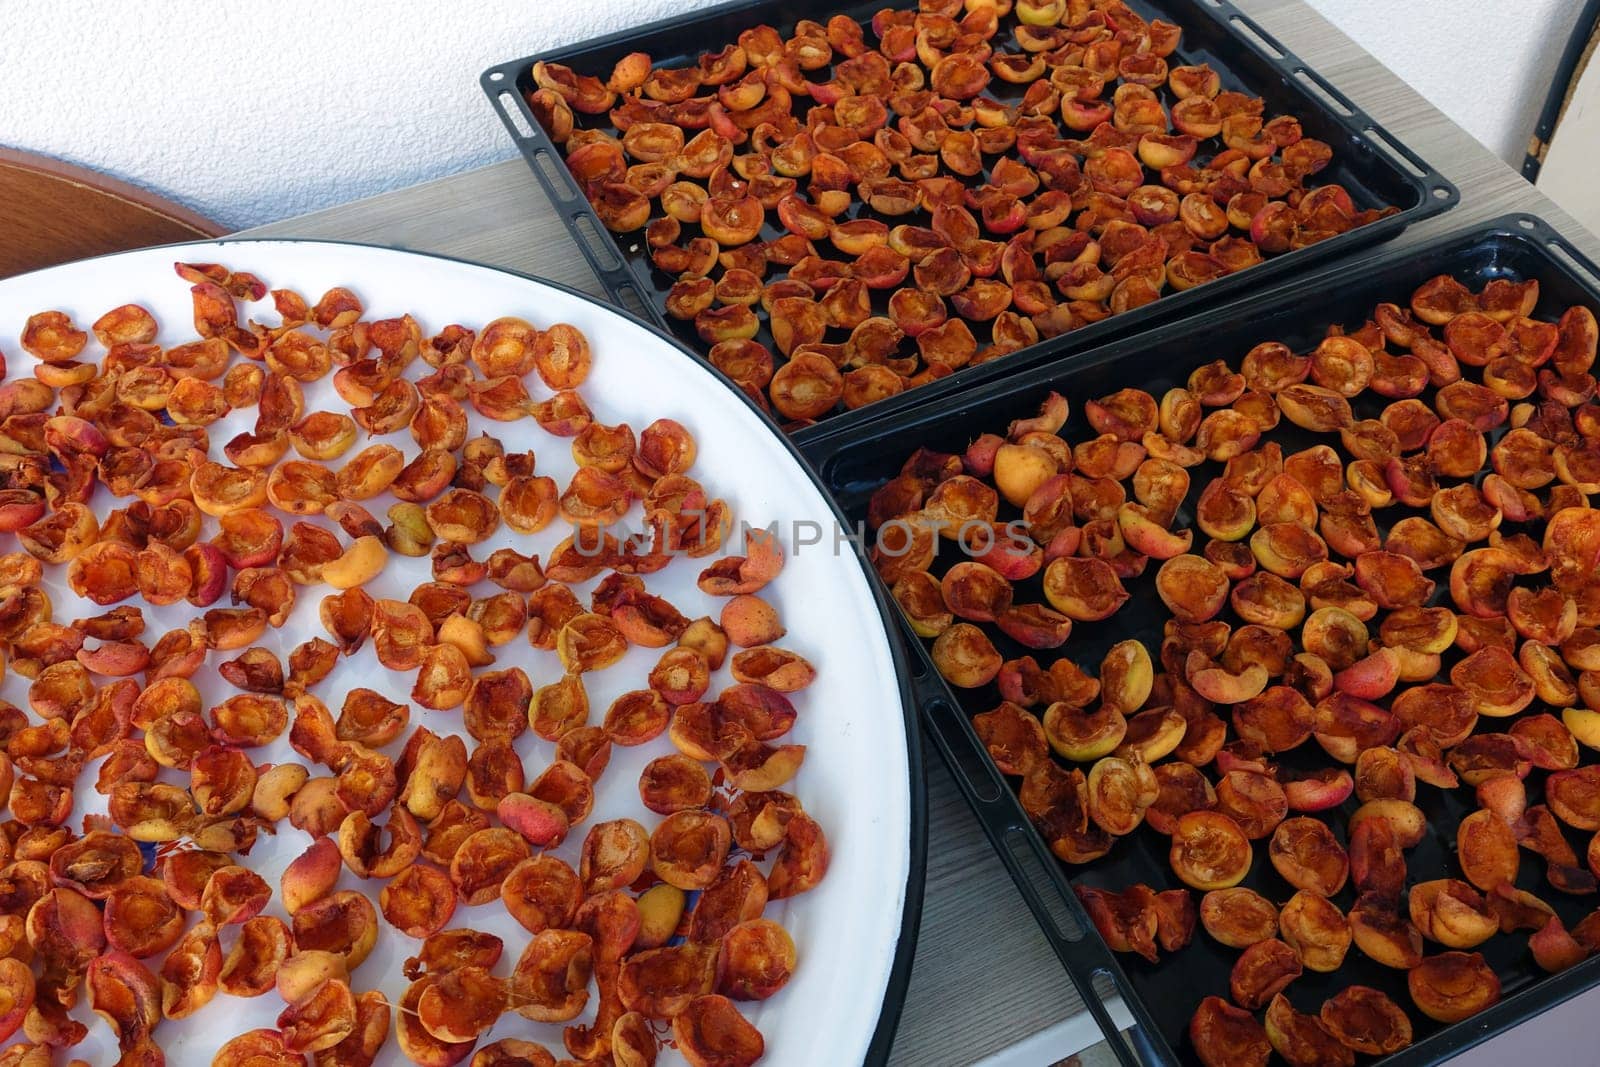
[869,277,1600,1067]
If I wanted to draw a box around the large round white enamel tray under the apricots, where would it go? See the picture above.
[0,242,922,1067]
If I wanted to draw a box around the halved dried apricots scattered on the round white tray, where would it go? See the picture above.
[0,264,829,1067]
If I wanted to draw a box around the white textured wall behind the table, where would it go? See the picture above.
[0,0,1579,227]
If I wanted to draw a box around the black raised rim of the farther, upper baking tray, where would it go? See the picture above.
[478,0,1461,443]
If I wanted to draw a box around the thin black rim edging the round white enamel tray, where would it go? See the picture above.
[8,235,928,1065]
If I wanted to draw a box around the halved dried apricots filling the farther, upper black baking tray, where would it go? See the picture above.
[528,0,1392,427]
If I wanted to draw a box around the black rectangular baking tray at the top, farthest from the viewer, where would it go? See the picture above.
[480,0,1461,440]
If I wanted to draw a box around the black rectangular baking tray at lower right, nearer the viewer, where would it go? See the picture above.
[802,216,1600,1067]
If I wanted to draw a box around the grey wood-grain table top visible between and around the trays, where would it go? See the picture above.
[245,0,1600,1067]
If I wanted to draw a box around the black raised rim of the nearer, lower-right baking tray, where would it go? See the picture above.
[802,211,1600,1067]
